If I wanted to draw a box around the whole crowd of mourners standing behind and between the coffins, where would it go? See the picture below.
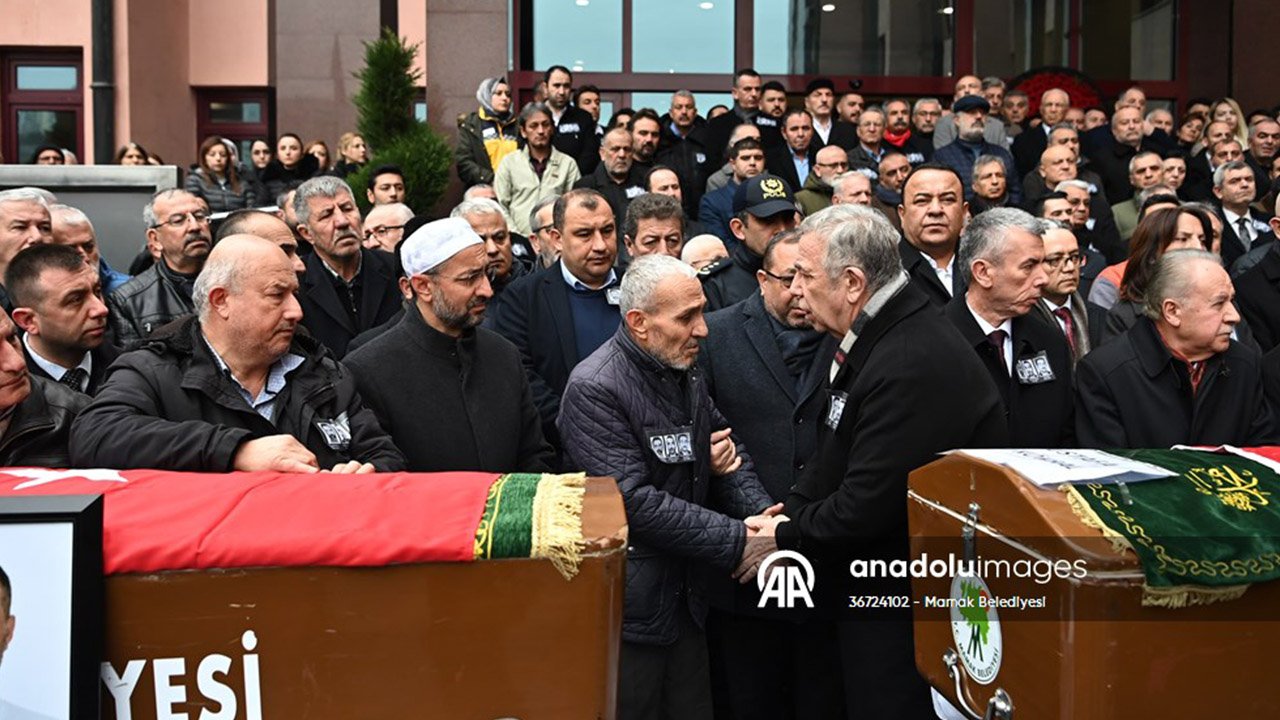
[0,67,1280,719]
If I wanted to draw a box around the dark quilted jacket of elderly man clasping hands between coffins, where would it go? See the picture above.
[557,327,773,644]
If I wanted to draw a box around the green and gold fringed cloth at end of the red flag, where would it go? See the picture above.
[475,473,586,579]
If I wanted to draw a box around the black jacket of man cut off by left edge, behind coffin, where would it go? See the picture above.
[0,375,88,468]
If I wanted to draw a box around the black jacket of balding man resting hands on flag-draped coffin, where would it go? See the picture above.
[70,318,404,473]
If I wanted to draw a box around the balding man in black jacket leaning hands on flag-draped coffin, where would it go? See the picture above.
[70,234,404,473]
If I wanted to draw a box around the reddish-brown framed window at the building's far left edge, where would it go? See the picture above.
[0,51,84,163]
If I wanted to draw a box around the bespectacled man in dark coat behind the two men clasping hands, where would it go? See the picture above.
[698,231,842,717]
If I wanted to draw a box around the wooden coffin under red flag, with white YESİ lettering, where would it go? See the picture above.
[0,469,626,720]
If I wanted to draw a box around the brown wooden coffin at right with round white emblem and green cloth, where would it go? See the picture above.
[908,447,1280,720]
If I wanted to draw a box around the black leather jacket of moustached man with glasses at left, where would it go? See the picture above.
[106,260,195,350]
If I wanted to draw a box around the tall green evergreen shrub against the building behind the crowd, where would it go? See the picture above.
[347,28,453,213]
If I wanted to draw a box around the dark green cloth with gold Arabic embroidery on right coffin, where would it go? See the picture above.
[1069,450,1280,607]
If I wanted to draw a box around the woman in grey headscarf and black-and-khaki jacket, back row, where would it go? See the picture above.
[454,77,518,187]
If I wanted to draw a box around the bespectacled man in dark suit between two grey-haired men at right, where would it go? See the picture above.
[1032,223,1106,368]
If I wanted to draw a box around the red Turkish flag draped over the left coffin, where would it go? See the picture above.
[0,468,498,575]
